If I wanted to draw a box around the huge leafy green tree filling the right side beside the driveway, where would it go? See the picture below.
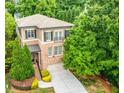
[64,0,119,86]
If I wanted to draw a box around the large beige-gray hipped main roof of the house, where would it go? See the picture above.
[16,14,73,28]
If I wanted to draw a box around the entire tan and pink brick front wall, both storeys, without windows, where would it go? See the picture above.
[21,28,65,69]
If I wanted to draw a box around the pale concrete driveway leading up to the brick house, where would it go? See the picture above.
[48,63,88,93]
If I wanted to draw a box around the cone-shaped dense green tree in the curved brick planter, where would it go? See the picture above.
[10,43,34,81]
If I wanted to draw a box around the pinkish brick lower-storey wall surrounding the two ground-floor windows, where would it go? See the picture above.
[41,42,63,69]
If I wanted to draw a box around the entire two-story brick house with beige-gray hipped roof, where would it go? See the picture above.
[16,14,73,69]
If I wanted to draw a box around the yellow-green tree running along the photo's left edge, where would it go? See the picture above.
[5,12,15,70]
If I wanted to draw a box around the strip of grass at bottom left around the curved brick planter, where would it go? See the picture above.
[5,74,55,93]
